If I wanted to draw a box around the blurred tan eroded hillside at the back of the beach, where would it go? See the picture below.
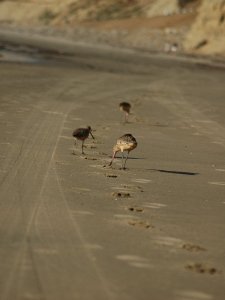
[0,0,225,56]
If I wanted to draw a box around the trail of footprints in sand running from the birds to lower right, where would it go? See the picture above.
[69,121,222,275]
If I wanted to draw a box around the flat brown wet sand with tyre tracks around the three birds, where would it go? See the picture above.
[0,31,225,300]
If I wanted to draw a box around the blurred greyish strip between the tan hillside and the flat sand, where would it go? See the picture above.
[0,24,225,68]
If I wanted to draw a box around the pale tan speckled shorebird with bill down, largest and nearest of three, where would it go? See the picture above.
[109,133,137,170]
